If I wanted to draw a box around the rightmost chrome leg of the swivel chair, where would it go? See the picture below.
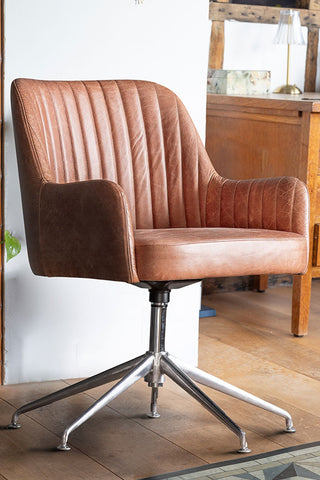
[169,355,296,433]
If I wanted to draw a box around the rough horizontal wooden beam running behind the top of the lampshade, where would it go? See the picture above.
[209,2,320,28]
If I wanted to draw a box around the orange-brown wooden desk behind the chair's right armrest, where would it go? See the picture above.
[206,93,320,336]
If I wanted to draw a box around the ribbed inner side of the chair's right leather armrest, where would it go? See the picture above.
[206,175,309,238]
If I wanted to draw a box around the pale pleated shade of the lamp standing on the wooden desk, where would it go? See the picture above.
[273,10,305,45]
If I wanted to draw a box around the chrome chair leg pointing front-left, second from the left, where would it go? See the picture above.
[57,354,154,450]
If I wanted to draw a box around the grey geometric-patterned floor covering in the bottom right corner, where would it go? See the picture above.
[144,442,320,480]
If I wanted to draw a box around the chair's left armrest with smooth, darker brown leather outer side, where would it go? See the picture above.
[39,180,138,283]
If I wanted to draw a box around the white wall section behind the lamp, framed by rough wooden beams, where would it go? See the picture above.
[223,20,307,91]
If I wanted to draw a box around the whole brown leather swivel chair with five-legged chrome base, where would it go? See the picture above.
[10,79,309,452]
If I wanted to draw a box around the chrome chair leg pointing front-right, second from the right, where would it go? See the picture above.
[161,355,251,453]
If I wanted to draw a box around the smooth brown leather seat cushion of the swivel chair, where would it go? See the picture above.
[134,227,308,281]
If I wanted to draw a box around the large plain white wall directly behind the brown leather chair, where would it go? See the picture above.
[4,0,209,383]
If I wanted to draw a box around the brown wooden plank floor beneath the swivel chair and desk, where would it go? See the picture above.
[0,280,320,480]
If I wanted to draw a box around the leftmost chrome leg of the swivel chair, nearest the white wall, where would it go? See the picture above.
[8,354,146,428]
